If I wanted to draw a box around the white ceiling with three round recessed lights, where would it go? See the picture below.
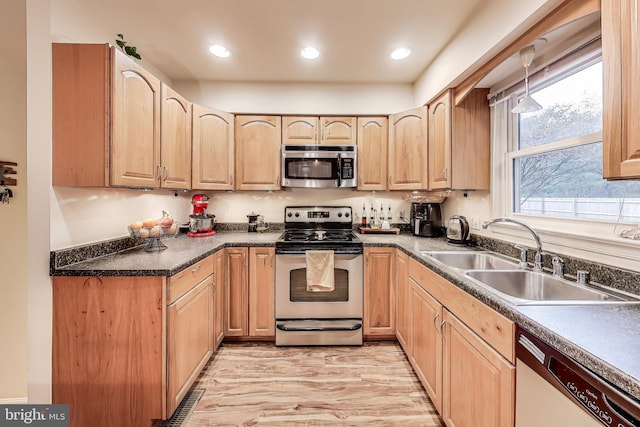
[69,0,484,83]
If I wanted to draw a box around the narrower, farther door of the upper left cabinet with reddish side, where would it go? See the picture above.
[160,84,191,190]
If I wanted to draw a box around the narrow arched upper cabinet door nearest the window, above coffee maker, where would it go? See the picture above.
[429,90,452,190]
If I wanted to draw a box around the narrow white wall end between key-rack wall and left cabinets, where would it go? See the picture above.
[26,0,52,403]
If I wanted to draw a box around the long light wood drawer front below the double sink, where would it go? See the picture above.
[409,259,515,363]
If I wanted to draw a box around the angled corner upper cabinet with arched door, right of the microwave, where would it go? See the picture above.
[388,107,428,190]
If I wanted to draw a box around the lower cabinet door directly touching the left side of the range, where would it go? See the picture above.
[249,248,276,337]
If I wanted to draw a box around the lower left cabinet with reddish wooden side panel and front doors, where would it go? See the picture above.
[52,256,214,427]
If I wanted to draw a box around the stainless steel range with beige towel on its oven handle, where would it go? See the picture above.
[275,206,364,345]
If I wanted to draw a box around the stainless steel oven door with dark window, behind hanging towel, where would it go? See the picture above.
[275,254,363,319]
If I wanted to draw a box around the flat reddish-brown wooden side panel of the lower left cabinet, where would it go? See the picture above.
[51,276,167,427]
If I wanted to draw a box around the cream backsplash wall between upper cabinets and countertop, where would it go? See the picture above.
[51,187,438,250]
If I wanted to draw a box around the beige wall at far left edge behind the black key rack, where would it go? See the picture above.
[0,0,28,404]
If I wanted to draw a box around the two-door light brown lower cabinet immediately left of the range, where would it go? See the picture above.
[225,247,275,339]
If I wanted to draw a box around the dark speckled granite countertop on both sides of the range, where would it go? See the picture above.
[51,232,640,400]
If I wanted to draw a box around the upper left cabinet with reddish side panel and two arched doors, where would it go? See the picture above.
[52,43,191,189]
